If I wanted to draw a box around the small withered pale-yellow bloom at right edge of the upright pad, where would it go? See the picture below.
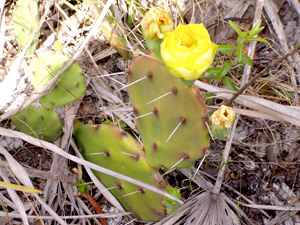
[211,105,235,129]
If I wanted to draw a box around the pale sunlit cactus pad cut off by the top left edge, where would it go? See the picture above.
[13,0,40,55]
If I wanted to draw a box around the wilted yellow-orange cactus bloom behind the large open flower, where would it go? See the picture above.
[141,8,174,39]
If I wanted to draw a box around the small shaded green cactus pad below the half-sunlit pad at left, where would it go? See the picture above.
[11,103,62,141]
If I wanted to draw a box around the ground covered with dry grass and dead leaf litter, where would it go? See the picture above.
[0,0,300,225]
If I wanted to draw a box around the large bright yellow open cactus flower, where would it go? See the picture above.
[160,23,218,80]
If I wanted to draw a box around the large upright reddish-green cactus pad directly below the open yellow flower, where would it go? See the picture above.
[128,55,210,168]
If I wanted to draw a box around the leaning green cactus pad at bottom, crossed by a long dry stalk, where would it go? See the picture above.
[73,123,165,221]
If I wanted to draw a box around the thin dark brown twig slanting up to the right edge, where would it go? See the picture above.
[227,48,299,106]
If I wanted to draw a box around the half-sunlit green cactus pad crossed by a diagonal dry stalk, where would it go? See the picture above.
[30,51,85,109]
